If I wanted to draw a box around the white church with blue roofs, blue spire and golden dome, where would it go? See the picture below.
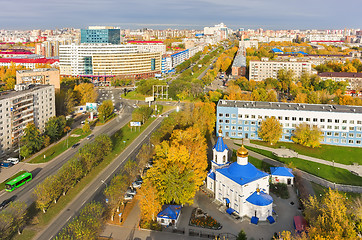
[207,129,273,221]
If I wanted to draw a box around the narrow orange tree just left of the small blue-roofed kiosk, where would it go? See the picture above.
[139,179,161,221]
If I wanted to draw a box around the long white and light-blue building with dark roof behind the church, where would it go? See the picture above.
[216,100,362,147]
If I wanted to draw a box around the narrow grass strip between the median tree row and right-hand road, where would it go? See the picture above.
[37,118,155,226]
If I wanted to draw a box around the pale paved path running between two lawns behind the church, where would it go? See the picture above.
[234,140,362,176]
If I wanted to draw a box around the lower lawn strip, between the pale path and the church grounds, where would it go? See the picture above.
[245,146,362,186]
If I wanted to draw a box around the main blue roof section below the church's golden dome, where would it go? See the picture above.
[216,162,269,185]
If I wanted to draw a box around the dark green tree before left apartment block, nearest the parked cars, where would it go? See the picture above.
[20,123,44,158]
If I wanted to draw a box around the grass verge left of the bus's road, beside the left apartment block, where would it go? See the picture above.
[29,128,90,163]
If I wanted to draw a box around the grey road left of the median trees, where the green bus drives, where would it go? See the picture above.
[0,99,133,205]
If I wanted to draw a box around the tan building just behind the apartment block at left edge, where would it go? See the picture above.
[16,68,60,89]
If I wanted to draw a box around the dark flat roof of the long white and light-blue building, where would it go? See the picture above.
[217,100,362,113]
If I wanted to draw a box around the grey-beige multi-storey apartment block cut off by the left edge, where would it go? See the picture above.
[0,84,55,154]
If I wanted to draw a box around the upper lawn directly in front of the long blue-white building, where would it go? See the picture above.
[250,140,362,165]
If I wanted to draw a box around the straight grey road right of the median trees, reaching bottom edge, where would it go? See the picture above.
[35,113,163,240]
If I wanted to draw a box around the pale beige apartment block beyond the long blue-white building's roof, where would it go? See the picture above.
[249,60,312,81]
